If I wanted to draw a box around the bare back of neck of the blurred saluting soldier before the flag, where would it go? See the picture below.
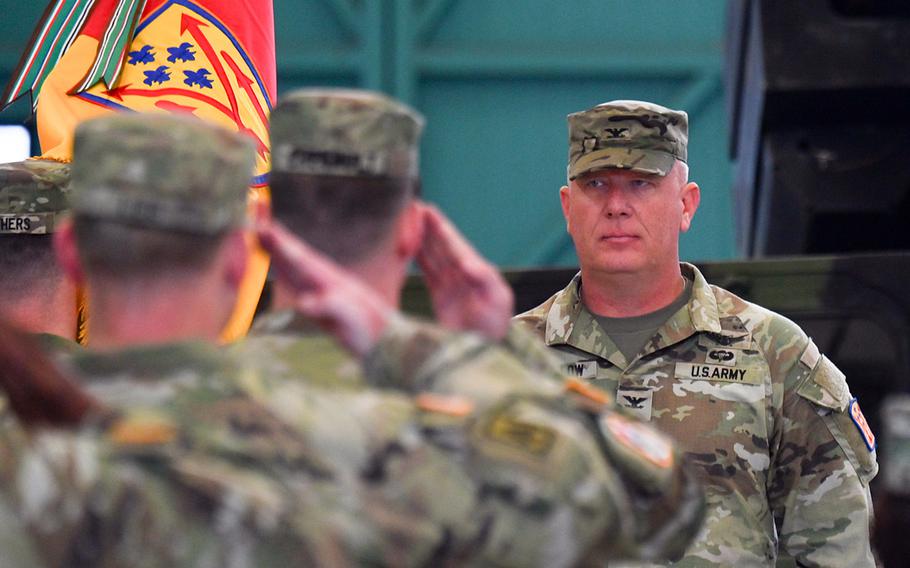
[88,285,235,351]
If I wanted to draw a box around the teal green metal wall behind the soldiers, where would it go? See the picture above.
[0,0,734,267]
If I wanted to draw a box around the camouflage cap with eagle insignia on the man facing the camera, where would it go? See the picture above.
[569,101,689,180]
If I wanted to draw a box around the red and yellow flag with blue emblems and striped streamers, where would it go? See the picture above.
[0,0,276,340]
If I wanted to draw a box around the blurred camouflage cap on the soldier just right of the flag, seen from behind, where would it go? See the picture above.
[270,89,423,177]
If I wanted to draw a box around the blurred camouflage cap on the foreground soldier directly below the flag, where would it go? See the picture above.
[71,114,255,234]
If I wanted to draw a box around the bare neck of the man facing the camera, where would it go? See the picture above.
[581,263,686,318]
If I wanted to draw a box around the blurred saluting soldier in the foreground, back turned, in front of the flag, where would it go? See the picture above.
[0,110,701,566]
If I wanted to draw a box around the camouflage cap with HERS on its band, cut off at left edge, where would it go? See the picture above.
[0,159,70,235]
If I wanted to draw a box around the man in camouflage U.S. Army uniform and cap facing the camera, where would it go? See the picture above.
[518,101,878,567]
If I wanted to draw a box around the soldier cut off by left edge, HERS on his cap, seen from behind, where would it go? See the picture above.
[0,159,76,340]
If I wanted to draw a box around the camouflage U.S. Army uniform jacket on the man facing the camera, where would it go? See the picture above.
[517,264,878,566]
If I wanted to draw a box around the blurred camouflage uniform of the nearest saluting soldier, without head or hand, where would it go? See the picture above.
[0,322,702,566]
